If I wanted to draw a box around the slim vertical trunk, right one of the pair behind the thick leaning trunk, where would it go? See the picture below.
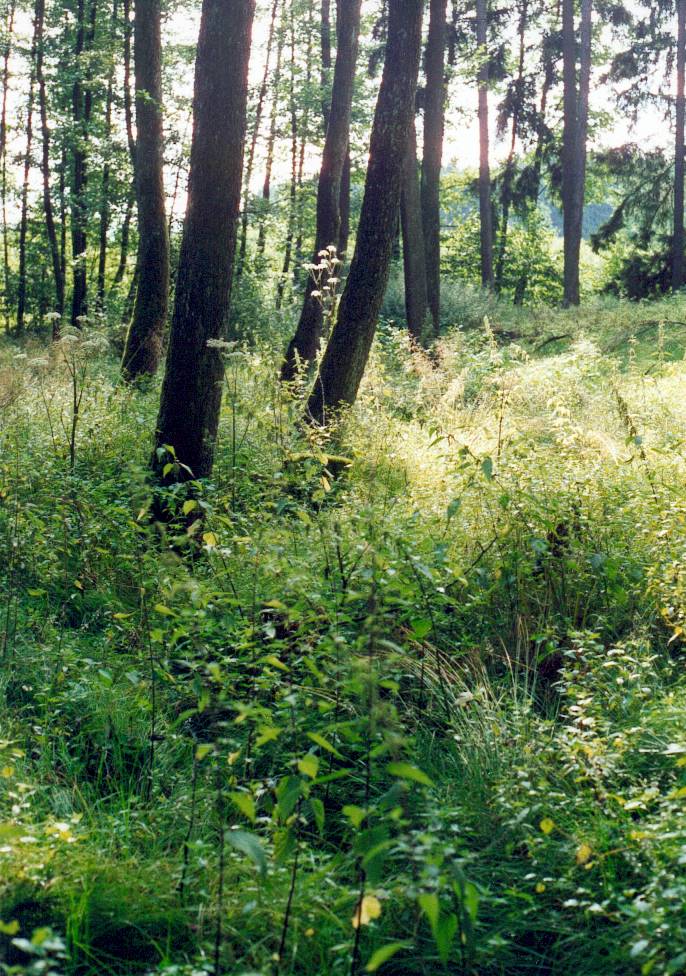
[422,0,447,335]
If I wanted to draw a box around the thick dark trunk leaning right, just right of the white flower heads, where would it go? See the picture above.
[307,0,424,424]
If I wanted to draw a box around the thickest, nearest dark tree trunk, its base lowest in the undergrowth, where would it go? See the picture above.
[153,0,255,480]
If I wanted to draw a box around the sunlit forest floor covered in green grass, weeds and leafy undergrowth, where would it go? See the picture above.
[0,290,686,976]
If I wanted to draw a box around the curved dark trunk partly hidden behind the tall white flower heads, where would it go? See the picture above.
[281,0,361,380]
